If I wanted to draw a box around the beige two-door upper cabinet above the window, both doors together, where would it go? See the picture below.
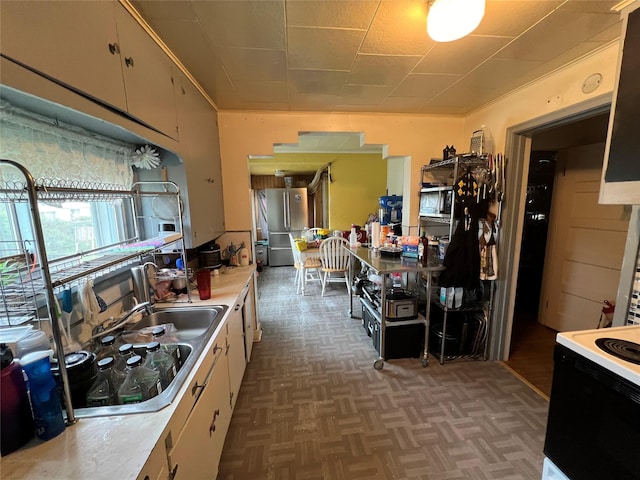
[0,0,178,140]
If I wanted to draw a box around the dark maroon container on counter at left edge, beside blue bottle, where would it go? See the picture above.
[0,344,35,456]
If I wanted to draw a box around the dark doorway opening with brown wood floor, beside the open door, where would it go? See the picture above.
[506,111,609,396]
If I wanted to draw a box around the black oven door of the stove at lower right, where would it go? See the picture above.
[544,344,640,480]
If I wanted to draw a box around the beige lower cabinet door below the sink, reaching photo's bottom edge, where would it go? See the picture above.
[169,344,231,480]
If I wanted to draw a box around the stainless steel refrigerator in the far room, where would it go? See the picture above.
[266,188,308,266]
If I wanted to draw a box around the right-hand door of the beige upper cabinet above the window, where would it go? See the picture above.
[116,6,178,140]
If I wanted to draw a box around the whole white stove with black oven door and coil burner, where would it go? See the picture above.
[543,325,640,480]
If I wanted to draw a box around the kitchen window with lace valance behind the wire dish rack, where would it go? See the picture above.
[0,99,135,261]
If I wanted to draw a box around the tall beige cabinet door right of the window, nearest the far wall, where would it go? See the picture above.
[177,76,224,247]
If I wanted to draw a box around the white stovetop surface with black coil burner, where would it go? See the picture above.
[556,325,640,385]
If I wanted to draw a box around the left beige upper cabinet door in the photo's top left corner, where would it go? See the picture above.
[0,1,126,110]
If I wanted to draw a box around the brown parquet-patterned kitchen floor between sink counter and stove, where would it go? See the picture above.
[218,267,548,480]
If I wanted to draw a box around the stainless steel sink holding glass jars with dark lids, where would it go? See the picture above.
[74,305,227,418]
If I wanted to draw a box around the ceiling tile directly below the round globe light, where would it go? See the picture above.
[414,35,509,74]
